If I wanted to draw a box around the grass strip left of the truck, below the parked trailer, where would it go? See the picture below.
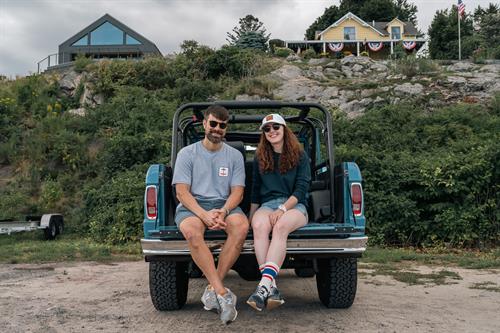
[0,232,142,264]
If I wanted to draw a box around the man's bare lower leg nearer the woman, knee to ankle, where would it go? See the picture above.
[219,214,249,278]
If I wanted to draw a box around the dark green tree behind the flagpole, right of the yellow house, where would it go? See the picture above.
[429,6,479,59]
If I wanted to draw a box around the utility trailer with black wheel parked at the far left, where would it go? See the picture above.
[0,214,64,240]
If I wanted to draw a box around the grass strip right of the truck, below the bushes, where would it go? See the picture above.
[361,247,500,269]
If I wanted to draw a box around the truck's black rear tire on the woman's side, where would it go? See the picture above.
[316,258,358,309]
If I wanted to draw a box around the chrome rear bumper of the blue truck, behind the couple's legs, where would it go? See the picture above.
[141,236,368,256]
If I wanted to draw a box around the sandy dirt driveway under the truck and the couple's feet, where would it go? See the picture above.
[0,262,500,333]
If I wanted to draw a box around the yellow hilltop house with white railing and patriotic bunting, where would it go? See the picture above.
[285,12,426,58]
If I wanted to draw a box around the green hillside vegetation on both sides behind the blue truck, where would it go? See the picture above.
[0,41,500,247]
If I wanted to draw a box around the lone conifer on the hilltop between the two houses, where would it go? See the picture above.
[227,15,271,51]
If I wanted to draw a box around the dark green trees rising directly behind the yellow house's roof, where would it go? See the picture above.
[306,0,417,40]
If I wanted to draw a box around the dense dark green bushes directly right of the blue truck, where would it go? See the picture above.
[334,105,500,247]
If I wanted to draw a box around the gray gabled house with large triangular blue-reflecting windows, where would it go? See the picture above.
[58,14,161,64]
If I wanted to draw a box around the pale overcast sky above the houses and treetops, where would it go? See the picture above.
[0,0,500,76]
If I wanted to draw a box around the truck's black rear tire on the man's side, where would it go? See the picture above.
[149,261,189,311]
